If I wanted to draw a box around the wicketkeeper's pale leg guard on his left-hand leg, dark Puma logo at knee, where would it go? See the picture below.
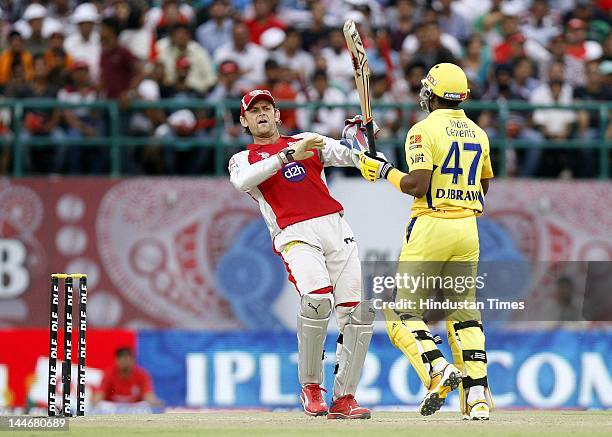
[297,294,332,385]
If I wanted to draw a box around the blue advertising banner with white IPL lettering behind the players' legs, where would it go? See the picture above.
[138,330,612,408]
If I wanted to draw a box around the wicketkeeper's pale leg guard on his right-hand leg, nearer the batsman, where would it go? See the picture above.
[334,301,376,399]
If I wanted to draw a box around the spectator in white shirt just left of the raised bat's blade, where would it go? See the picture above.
[315,28,355,92]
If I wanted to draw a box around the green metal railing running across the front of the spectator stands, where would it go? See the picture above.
[0,99,612,179]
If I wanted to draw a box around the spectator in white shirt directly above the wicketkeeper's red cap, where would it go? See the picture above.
[215,22,268,87]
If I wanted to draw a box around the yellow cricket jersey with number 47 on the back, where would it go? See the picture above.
[406,109,493,218]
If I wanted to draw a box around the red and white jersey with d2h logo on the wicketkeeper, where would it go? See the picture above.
[229,133,354,238]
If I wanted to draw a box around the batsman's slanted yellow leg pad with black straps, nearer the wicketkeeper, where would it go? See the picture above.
[385,310,444,387]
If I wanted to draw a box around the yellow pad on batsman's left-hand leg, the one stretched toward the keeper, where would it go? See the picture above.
[385,310,441,387]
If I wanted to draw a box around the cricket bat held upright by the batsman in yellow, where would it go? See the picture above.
[342,20,376,156]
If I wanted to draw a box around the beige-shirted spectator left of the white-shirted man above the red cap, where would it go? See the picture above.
[157,24,217,94]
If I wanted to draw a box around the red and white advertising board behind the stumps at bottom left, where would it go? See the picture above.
[0,329,136,407]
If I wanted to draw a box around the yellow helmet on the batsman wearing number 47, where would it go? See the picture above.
[421,62,470,112]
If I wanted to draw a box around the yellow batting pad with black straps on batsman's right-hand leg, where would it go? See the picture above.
[446,320,493,414]
